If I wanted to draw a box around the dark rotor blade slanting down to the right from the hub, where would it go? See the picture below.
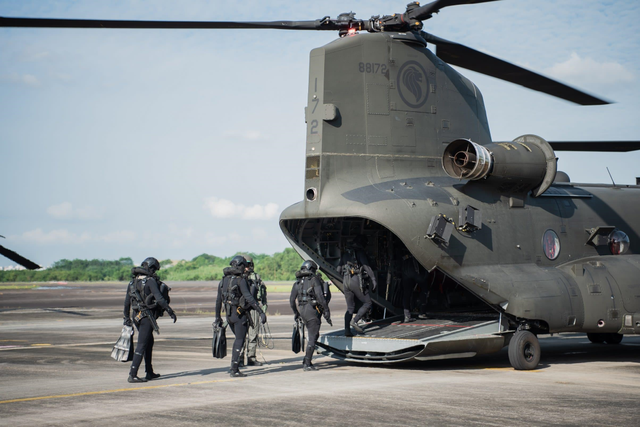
[422,32,610,105]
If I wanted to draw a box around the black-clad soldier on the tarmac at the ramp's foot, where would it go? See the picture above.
[289,260,333,371]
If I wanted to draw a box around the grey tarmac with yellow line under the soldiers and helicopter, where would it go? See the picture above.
[0,282,640,426]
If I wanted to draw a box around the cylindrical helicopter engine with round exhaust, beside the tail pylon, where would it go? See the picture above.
[442,135,557,197]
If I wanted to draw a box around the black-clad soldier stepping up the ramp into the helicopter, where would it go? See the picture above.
[338,235,378,337]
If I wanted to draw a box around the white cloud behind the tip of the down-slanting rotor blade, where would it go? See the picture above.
[547,52,635,85]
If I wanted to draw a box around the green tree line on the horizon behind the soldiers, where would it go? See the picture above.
[0,248,302,282]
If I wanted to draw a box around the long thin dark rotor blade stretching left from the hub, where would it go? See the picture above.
[0,17,346,30]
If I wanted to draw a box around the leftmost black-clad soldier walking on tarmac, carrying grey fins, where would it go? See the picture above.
[124,257,177,383]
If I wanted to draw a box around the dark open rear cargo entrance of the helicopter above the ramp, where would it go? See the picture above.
[281,217,499,321]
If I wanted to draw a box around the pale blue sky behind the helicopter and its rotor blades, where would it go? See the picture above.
[0,0,640,266]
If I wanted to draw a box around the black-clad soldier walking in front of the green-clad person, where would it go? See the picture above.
[215,255,267,377]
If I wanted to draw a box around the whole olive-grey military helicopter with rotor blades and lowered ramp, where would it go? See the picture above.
[0,0,640,369]
